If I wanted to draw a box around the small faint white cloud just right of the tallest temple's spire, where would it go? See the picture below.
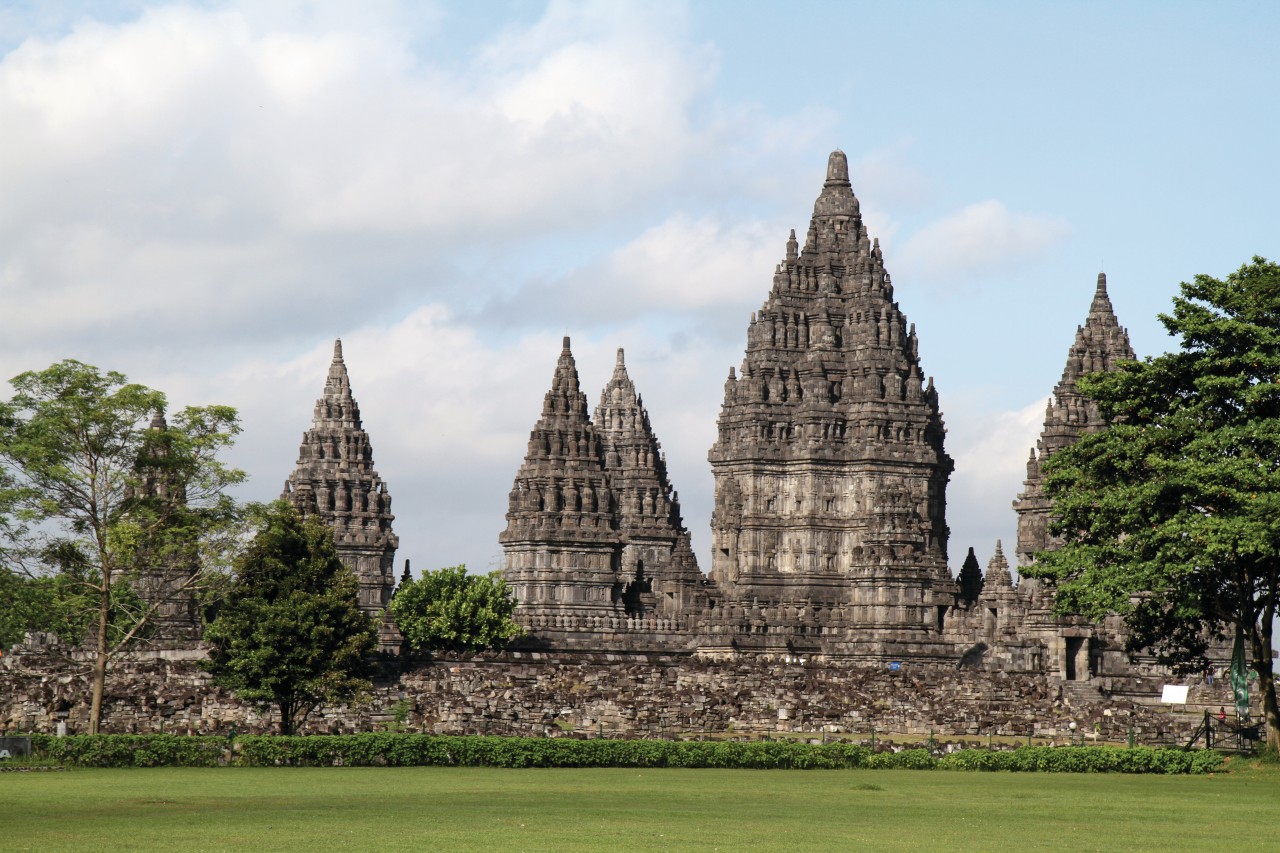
[896,201,1071,278]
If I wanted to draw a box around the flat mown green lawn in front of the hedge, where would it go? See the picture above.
[0,762,1280,853]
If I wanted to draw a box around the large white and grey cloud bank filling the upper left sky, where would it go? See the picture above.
[0,4,742,342]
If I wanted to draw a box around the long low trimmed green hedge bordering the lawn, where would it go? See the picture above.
[32,733,1222,774]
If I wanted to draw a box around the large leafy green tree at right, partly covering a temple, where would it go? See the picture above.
[1024,257,1280,751]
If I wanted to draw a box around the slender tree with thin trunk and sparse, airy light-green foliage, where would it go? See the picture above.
[0,360,244,733]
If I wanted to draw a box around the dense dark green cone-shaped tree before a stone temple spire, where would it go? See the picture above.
[205,501,378,734]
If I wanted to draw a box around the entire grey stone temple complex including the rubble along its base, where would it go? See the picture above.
[0,151,1249,739]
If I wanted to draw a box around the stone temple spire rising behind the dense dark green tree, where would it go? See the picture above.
[282,339,399,613]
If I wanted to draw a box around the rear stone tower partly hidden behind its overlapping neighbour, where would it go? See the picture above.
[595,348,703,616]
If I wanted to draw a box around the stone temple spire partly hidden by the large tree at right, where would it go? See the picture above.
[1014,273,1137,566]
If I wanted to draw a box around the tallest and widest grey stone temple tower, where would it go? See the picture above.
[709,151,957,660]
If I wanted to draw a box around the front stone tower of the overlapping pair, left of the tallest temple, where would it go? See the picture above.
[498,337,621,635]
